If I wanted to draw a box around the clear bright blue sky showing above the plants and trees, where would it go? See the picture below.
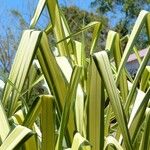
[0,0,149,30]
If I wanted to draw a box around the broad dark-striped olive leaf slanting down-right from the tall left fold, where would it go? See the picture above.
[37,32,68,117]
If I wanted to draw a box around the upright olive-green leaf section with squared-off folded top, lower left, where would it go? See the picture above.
[41,95,55,150]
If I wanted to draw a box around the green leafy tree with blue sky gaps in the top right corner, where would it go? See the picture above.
[91,0,150,49]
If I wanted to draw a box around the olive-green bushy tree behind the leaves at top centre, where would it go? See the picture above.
[62,6,109,54]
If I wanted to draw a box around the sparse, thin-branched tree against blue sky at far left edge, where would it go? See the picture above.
[0,0,41,77]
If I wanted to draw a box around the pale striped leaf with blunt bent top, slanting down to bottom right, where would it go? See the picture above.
[93,51,132,150]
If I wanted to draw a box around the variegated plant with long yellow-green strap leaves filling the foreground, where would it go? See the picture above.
[0,0,150,150]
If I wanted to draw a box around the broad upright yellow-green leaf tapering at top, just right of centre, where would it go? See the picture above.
[87,60,105,150]
